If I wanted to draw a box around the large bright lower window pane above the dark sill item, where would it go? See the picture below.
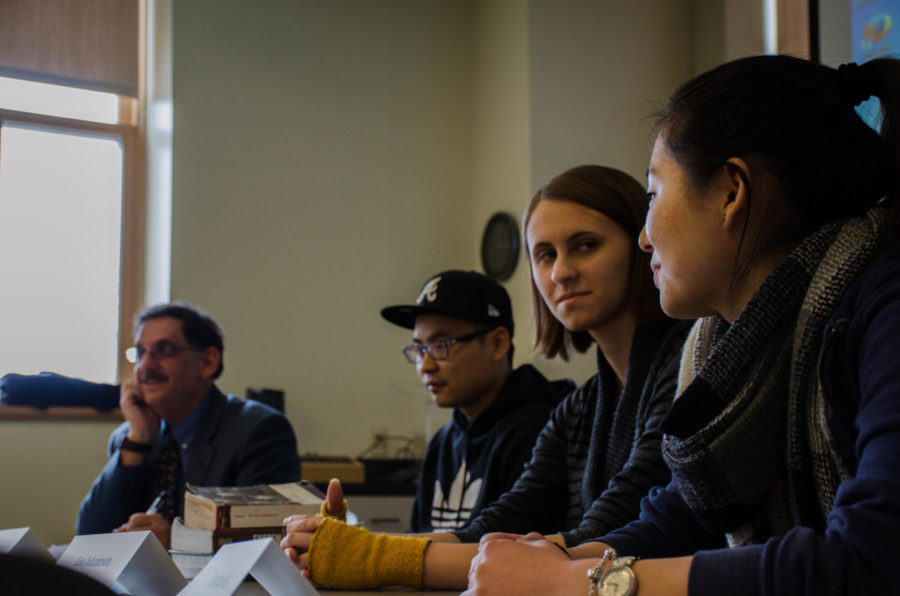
[0,125,122,382]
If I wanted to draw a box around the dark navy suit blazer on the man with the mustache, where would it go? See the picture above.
[75,386,300,534]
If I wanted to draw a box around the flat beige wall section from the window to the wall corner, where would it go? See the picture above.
[172,0,475,454]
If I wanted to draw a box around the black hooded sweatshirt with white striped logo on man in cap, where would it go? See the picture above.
[410,365,562,532]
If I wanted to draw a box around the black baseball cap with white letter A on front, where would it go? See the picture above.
[381,269,514,337]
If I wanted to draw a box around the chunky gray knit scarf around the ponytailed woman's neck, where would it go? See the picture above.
[662,208,886,546]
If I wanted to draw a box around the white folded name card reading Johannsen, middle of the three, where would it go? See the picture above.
[59,530,187,596]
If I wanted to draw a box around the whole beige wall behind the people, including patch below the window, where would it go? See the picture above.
[0,0,768,543]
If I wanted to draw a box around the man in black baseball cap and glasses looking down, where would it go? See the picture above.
[381,270,562,532]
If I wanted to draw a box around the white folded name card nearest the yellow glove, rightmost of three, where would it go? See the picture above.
[178,538,318,596]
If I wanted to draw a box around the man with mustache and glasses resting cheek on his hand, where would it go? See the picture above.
[77,302,300,546]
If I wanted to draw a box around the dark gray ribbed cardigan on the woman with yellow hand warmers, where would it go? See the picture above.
[454,320,691,546]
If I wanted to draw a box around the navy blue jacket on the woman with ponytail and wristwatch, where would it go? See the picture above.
[600,255,900,596]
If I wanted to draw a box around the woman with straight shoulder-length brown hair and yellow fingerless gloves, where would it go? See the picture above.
[282,166,689,589]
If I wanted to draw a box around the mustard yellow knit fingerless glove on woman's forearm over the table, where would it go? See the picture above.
[307,519,431,590]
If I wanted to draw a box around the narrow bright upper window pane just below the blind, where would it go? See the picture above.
[0,77,119,124]
